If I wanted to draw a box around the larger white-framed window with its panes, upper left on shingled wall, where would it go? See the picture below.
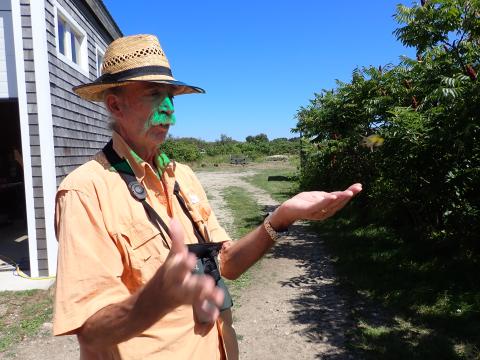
[55,3,88,77]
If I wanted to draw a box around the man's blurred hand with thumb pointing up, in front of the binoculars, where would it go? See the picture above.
[154,220,224,323]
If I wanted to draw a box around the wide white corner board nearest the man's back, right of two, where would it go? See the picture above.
[30,0,57,276]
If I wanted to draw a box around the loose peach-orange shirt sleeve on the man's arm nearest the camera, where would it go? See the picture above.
[53,190,130,335]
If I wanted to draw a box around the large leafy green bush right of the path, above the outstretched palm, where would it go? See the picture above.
[296,0,480,253]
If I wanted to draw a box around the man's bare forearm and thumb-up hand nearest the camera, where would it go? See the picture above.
[77,220,224,348]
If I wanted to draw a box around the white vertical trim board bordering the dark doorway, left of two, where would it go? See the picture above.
[11,0,38,277]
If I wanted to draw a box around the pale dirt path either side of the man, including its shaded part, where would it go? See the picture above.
[0,168,353,360]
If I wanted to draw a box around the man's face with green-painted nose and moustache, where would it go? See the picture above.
[110,83,175,149]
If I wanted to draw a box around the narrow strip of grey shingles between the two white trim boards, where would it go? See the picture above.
[20,0,48,276]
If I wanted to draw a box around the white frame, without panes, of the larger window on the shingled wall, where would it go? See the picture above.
[54,2,89,78]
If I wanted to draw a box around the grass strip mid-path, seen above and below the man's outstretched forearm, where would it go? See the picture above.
[222,186,263,302]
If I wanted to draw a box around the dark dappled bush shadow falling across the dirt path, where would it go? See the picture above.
[269,224,354,360]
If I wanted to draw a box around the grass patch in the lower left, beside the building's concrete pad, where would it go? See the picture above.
[0,290,53,352]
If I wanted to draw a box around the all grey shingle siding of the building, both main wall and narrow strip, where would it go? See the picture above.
[16,0,119,276]
